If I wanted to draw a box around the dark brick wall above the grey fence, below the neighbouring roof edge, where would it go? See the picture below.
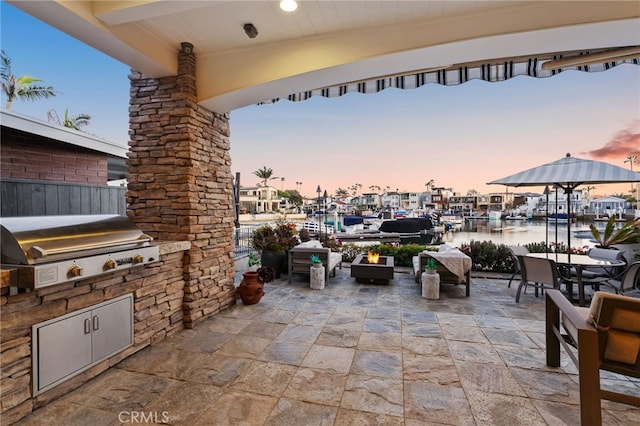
[0,127,108,185]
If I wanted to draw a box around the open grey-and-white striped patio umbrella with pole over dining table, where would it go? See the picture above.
[488,154,640,260]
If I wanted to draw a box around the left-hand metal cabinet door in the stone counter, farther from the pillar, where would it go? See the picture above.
[35,312,91,389]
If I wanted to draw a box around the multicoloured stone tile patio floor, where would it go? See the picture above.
[19,265,640,426]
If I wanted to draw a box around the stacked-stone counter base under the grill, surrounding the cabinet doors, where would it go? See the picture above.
[0,243,189,424]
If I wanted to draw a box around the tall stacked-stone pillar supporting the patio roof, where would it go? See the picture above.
[127,43,235,328]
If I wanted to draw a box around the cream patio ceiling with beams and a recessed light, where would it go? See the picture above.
[7,0,640,112]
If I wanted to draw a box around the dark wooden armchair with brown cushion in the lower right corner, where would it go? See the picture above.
[546,290,640,425]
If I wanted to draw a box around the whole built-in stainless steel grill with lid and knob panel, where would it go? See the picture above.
[0,215,159,289]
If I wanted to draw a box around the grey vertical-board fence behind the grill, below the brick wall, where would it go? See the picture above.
[0,178,127,217]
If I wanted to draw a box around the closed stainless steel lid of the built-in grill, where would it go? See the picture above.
[0,215,153,265]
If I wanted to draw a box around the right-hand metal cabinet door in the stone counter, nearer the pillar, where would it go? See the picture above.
[91,298,133,362]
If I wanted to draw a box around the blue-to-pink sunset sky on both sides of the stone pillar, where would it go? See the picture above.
[0,2,640,197]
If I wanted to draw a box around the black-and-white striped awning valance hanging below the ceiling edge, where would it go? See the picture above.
[261,46,640,104]
